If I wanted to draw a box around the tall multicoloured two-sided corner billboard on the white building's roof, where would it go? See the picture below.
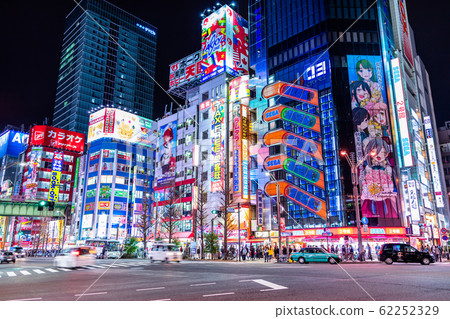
[201,5,248,82]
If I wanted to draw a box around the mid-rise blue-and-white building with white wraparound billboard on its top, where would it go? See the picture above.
[72,108,156,240]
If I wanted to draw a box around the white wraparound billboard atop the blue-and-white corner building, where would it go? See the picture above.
[88,108,155,146]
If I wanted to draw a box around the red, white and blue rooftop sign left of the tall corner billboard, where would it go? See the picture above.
[169,50,202,89]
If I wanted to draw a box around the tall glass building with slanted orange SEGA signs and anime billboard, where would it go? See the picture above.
[249,0,448,248]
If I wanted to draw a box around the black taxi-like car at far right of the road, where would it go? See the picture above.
[379,244,435,265]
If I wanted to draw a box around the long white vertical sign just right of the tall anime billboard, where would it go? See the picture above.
[391,58,413,167]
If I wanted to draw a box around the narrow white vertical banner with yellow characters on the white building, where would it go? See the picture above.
[211,99,225,193]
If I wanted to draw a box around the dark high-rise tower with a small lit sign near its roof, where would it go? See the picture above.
[53,0,157,134]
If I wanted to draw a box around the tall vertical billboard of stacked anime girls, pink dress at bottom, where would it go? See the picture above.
[347,55,399,218]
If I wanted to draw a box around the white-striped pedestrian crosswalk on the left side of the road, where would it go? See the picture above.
[0,261,149,279]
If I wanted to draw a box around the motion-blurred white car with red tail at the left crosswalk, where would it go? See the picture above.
[54,247,97,268]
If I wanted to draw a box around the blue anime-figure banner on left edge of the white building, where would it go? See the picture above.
[156,121,177,188]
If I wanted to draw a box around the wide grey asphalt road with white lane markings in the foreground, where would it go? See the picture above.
[0,258,450,301]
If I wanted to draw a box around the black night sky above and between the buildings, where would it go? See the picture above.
[0,0,450,129]
